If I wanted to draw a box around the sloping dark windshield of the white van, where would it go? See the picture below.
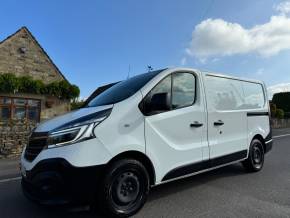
[87,69,164,107]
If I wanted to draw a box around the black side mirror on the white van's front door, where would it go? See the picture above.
[149,92,170,112]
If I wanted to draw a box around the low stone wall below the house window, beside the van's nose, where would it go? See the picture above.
[0,120,36,159]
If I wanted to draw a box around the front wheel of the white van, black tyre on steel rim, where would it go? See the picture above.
[96,159,150,217]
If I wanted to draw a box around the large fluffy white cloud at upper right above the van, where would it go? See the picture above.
[186,1,290,60]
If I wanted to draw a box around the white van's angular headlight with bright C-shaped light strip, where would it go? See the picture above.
[47,109,111,148]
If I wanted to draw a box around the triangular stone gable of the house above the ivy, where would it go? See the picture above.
[0,27,64,83]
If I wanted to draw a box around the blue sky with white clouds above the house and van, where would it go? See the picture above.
[0,0,290,98]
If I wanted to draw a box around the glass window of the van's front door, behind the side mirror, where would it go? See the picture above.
[141,72,196,115]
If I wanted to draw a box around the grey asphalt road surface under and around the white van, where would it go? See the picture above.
[0,132,290,218]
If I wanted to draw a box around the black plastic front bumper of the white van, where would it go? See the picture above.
[21,158,105,205]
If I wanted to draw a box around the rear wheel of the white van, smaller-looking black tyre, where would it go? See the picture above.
[242,139,264,172]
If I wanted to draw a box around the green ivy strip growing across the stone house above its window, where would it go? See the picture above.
[0,73,80,100]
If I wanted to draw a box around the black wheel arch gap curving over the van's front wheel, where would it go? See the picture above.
[108,150,156,185]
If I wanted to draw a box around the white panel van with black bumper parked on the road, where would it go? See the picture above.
[21,68,272,217]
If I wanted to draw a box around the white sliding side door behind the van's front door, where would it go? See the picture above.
[205,74,247,162]
